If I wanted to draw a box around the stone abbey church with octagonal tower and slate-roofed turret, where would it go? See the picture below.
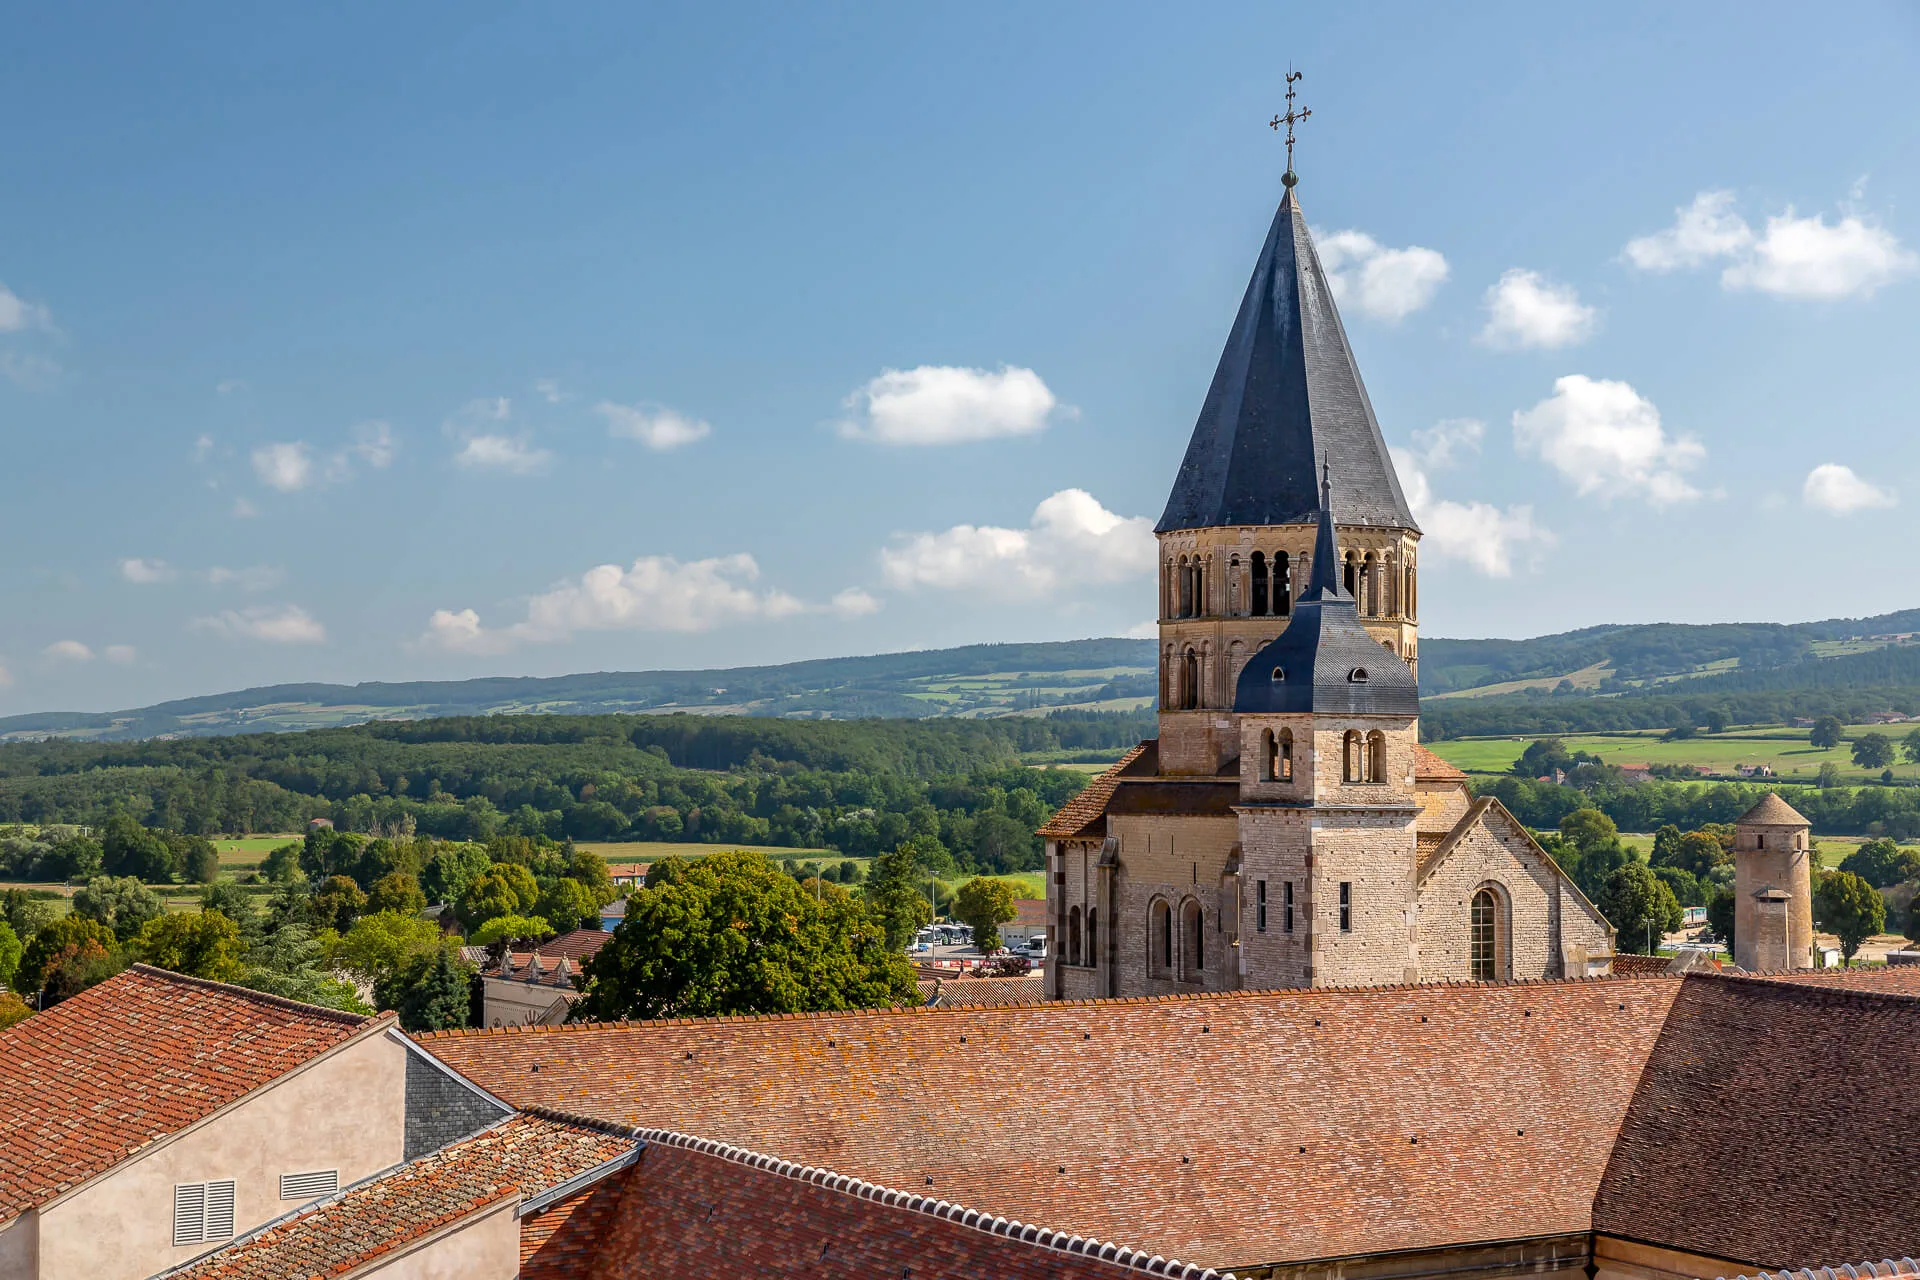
[1041,175,1613,1000]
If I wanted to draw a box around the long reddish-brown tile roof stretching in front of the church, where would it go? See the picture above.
[420,979,1682,1267]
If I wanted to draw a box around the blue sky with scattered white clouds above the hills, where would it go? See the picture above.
[0,2,1920,714]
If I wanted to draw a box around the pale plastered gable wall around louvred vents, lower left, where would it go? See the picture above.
[37,1034,407,1280]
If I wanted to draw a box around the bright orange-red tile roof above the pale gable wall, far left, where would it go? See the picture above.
[0,965,378,1222]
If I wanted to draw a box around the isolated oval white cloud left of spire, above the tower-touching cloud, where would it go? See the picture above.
[839,365,1075,445]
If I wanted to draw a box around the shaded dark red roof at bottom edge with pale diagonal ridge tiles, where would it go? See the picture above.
[560,1130,1217,1280]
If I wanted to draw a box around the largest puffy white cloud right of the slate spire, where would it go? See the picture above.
[1513,374,1707,507]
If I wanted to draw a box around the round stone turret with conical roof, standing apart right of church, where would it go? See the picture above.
[1734,791,1812,971]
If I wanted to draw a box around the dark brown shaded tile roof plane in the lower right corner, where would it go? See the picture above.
[1594,975,1920,1270]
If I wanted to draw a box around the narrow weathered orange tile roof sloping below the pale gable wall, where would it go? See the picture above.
[169,1113,637,1280]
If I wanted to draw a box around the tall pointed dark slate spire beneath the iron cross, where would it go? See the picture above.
[1156,192,1419,533]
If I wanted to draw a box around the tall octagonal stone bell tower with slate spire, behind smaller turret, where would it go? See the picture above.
[1154,169,1421,777]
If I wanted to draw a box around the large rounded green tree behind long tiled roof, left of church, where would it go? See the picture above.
[572,852,916,1019]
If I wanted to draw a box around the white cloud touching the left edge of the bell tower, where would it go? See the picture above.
[879,489,1156,599]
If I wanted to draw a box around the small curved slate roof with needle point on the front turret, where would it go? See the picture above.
[1233,470,1421,716]
